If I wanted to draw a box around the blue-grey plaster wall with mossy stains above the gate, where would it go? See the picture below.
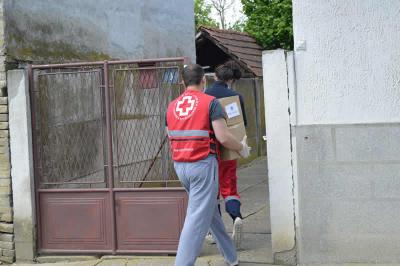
[5,0,195,62]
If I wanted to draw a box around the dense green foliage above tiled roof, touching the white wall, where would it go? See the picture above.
[241,0,293,50]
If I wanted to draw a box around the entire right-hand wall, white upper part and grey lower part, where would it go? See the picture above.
[290,0,400,265]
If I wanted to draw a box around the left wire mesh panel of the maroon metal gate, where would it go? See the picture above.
[33,69,106,188]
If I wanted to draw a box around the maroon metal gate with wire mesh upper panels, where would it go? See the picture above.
[29,58,187,254]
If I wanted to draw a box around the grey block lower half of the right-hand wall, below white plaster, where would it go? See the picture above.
[295,124,400,265]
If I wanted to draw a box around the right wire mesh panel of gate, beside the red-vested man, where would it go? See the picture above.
[110,63,182,187]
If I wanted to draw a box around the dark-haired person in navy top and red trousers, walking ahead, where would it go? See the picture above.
[205,61,247,248]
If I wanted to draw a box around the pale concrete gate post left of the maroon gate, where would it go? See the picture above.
[7,70,36,261]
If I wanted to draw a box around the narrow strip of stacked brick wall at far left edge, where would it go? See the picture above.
[0,0,15,263]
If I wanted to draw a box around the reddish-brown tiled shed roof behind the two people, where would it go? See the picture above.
[197,26,262,77]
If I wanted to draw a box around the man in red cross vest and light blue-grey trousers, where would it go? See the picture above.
[166,65,249,266]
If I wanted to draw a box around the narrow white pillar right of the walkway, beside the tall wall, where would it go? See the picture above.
[262,50,295,254]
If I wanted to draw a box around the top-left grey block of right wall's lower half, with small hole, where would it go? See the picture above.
[295,126,335,162]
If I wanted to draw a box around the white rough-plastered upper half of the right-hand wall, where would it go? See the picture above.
[293,0,400,125]
